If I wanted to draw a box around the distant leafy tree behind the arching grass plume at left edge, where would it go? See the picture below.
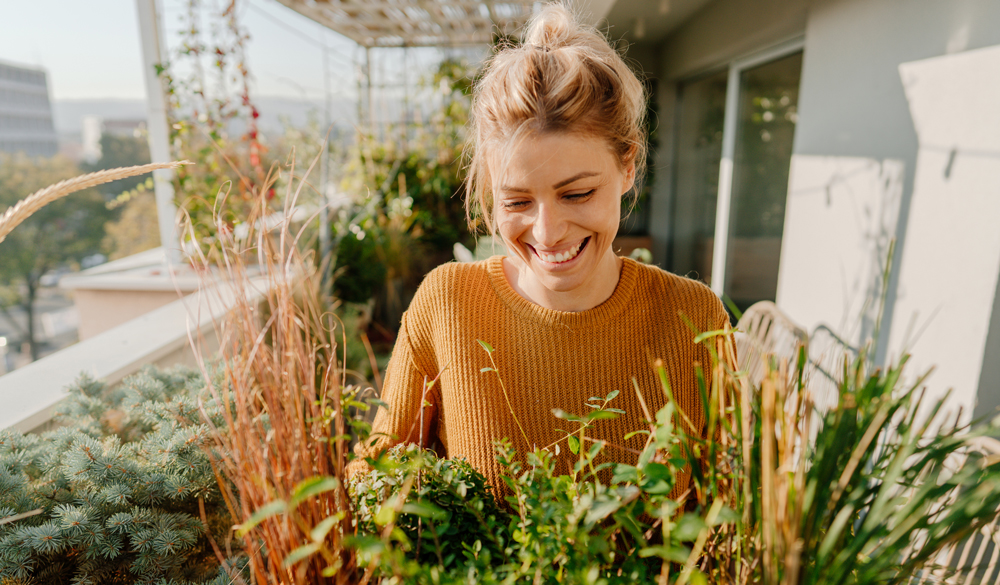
[0,154,110,359]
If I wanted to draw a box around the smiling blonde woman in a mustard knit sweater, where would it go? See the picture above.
[352,5,728,494]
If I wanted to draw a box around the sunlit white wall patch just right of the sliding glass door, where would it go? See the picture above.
[777,155,905,346]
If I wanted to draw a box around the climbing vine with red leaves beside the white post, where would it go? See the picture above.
[157,0,278,250]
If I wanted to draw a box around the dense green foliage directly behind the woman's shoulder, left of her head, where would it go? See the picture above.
[332,60,480,340]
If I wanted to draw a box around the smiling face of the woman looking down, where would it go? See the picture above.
[493,132,635,312]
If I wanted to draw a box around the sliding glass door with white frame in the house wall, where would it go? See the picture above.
[667,40,802,311]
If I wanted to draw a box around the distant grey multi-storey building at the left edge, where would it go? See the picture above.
[0,61,59,156]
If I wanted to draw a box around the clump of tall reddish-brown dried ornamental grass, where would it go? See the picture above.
[188,153,355,584]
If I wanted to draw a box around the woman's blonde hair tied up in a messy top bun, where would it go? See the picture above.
[465,4,646,233]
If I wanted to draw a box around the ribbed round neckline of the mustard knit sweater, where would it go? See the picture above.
[486,256,639,329]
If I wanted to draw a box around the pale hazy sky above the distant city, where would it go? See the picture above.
[0,0,362,100]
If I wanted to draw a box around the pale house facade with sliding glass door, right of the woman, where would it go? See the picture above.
[581,0,1000,418]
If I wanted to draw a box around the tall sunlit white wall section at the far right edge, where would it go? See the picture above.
[889,45,1000,418]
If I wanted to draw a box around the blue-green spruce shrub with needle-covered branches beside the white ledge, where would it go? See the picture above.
[0,369,236,584]
